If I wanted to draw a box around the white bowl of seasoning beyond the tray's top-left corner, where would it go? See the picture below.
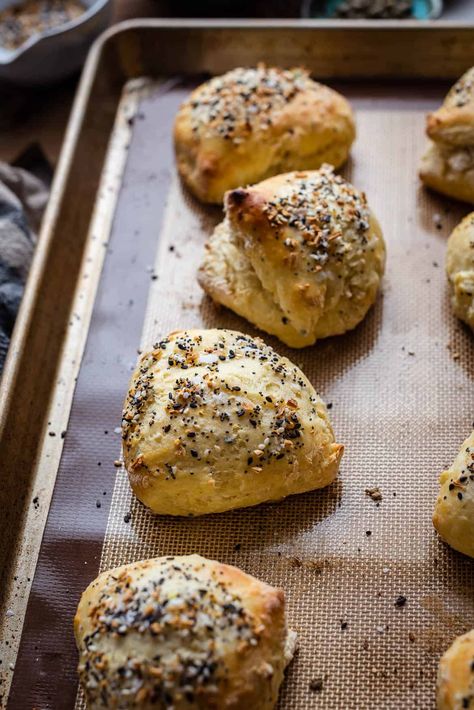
[0,0,111,86]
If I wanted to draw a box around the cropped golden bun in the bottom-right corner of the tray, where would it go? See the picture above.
[437,631,474,710]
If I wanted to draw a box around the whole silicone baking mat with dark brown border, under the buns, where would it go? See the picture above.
[10,73,474,710]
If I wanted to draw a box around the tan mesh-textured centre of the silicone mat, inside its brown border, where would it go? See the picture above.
[70,85,474,710]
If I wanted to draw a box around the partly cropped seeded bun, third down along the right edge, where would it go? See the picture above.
[433,432,474,560]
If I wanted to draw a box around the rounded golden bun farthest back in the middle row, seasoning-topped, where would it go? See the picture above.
[174,65,355,203]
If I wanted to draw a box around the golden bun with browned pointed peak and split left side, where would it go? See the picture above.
[198,165,385,348]
